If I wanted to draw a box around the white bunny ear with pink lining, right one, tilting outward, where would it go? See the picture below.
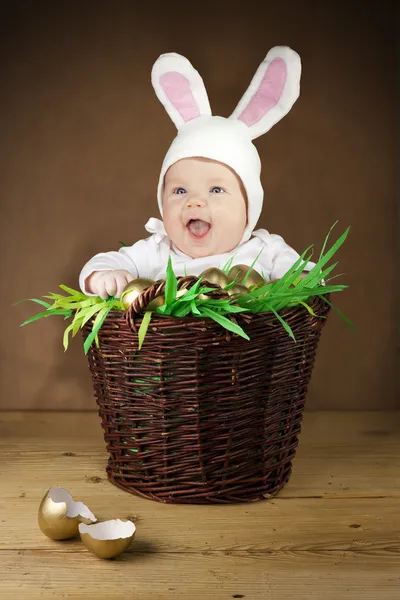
[230,46,301,140]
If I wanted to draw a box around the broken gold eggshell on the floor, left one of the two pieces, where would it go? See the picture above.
[38,487,97,540]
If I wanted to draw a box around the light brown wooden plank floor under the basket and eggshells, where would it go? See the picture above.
[0,412,400,600]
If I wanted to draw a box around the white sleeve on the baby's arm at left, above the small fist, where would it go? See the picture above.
[79,236,158,296]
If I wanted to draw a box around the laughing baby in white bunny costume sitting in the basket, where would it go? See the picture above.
[79,47,314,299]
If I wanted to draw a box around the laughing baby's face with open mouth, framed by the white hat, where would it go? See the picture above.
[162,158,247,258]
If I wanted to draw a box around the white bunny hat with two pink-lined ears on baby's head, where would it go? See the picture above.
[152,46,301,243]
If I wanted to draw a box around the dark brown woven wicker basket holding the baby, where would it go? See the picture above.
[83,278,329,504]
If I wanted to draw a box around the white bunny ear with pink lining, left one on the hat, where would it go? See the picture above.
[151,52,211,129]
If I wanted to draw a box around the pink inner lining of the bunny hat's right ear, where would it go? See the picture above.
[239,58,287,127]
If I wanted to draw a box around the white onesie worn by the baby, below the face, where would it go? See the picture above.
[79,218,314,296]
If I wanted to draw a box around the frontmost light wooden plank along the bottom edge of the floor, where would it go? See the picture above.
[0,550,400,600]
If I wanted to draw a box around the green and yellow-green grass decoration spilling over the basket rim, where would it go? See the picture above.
[13,223,354,354]
